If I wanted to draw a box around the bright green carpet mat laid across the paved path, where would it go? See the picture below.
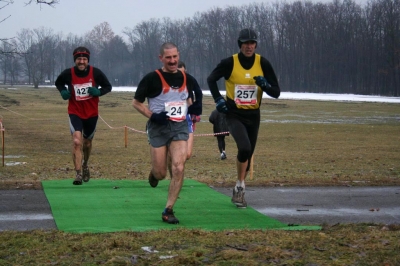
[42,179,321,233]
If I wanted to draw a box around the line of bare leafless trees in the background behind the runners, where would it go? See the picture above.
[0,0,400,96]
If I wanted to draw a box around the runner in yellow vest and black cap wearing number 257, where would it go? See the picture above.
[207,29,280,208]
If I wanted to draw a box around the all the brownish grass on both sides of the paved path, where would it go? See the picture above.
[0,88,400,265]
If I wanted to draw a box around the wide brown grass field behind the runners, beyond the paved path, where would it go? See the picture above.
[0,85,400,187]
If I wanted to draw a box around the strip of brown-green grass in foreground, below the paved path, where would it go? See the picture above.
[0,224,400,266]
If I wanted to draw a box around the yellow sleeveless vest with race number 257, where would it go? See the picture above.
[225,54,264,109]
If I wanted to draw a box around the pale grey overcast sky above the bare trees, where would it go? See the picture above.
[0,0,367,38]
